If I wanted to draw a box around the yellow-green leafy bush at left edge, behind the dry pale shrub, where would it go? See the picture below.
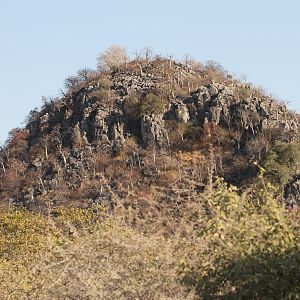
[0,206,105,262]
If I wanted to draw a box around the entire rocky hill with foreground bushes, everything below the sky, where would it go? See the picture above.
[0,46,300,300]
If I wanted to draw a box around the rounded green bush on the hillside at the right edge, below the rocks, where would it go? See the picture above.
[263,142,300,184]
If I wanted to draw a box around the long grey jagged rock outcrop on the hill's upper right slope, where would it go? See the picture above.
[186,83,299,134]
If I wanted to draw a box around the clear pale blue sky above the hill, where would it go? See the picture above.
[0,0,300,141]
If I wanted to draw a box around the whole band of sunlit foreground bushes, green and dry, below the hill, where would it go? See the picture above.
[0,179,300,299]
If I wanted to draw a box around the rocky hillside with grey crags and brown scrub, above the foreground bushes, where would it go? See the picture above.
[1,59,300,207]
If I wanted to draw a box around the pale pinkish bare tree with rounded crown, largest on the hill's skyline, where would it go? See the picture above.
[97,45,128,70]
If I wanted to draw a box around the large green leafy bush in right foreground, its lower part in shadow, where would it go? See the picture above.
[183,182,300,299]
